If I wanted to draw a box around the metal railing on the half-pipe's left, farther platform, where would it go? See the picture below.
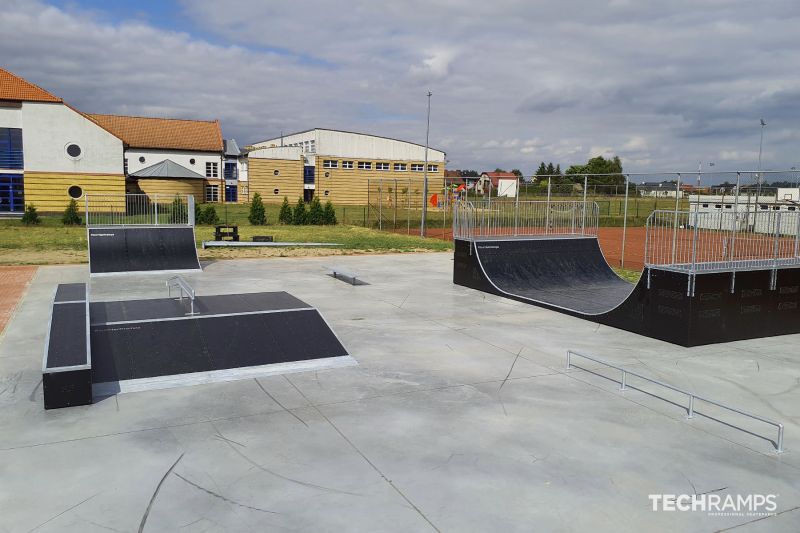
[453,199,599,239]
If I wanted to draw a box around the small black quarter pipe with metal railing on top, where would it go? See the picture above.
[86,194,201,276]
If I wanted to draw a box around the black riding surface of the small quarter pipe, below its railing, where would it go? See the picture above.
[89,226,200,274]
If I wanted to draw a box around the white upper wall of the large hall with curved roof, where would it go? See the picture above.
[255,129,445,163]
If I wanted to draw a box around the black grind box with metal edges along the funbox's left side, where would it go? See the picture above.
[42,283,92,409]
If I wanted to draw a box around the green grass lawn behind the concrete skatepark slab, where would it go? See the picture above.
[0,214,452,265]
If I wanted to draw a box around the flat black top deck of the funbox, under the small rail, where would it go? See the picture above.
[90,291,311,325]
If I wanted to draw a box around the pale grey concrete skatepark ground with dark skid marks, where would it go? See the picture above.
[0,254,800,532]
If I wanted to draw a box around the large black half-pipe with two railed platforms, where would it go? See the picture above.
[453,202,800,346]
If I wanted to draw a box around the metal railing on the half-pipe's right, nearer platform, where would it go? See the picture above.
[645,208,800,273]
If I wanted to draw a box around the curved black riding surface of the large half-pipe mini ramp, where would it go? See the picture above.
[475,237,634,314]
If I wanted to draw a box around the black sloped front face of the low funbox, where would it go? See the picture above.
[91,309,347,383]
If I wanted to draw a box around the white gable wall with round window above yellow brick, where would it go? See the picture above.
[21,102,122,174]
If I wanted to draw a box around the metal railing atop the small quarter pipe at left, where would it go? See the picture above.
[84,194,194,226]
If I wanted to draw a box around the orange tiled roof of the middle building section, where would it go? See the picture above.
[86,114,222,152]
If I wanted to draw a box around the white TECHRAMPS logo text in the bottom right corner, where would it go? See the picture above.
[647,494,778,518]
